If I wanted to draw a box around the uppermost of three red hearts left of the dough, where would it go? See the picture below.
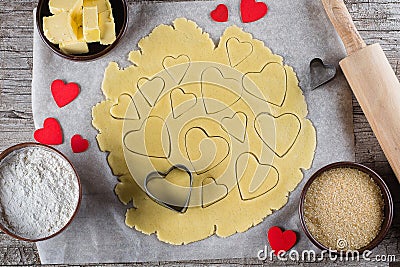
[51,80,79,108]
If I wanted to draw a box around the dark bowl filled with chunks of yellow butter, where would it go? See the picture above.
[36,0,128,61]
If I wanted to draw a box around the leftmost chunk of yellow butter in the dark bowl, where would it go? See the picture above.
[43,12,78,44]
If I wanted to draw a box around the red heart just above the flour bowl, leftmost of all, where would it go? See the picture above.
[33,118,63,145]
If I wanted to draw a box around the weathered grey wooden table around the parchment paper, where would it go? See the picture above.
[0,0,400,266]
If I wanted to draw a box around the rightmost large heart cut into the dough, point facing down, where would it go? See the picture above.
[254,113,301,158]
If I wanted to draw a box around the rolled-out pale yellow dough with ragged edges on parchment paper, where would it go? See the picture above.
[93,18,316,245]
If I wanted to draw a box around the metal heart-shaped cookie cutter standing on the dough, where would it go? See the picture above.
[144,164,193,213]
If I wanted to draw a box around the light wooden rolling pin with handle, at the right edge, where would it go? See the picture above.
[322,0,400,181]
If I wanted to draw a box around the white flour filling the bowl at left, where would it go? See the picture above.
[0,147,79,239]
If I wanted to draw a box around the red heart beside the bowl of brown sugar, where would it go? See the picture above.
[268,226,296,255]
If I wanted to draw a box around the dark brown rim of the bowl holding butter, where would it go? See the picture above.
[36,0,128,61]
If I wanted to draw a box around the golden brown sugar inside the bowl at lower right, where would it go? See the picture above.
[304,168,384,250]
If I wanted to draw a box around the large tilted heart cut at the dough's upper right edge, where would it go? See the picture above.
[243,62,287,107]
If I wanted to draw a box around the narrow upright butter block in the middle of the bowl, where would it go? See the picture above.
[82,6,100,43]
